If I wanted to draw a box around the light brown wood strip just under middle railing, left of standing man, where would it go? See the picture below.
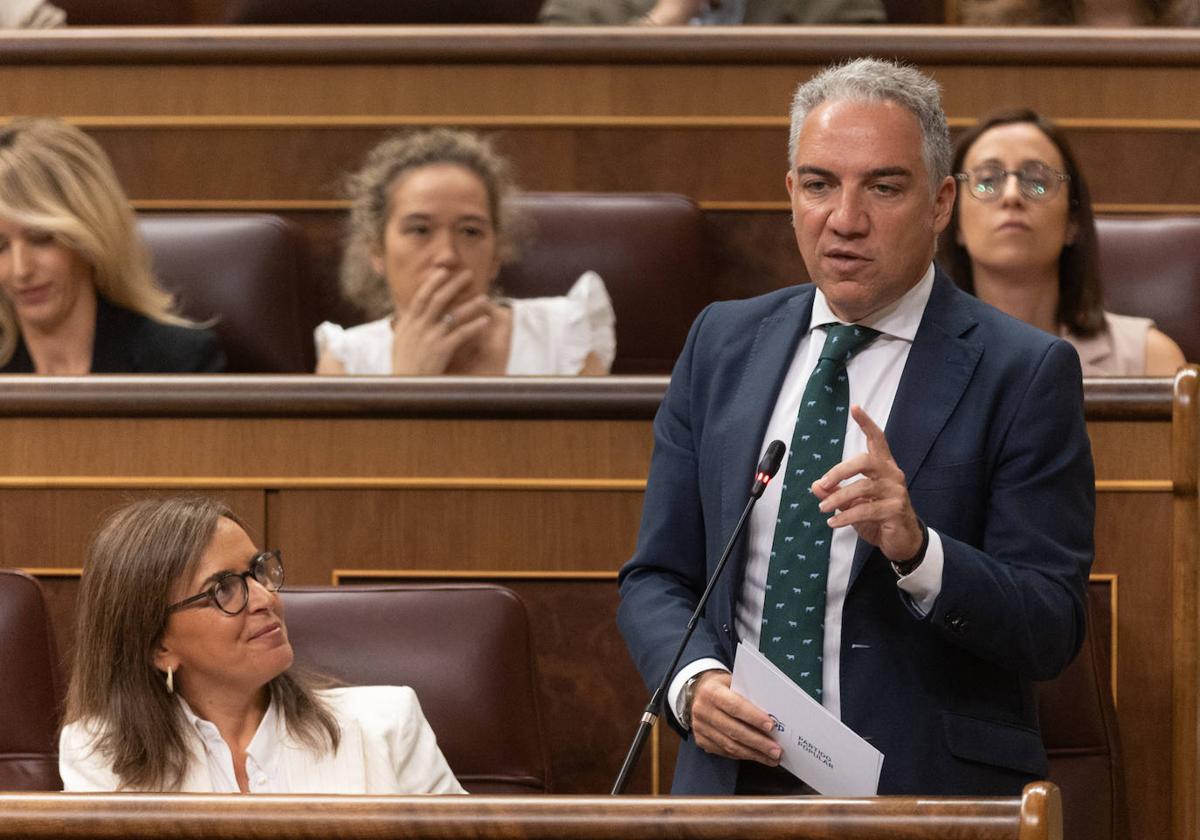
[0,418,652,475]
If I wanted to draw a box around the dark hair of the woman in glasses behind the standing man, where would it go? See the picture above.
[938,108,1104,337]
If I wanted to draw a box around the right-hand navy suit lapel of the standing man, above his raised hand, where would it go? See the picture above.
[850,271,983,586]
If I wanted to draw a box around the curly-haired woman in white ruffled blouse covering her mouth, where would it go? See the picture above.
[316,128,616,376]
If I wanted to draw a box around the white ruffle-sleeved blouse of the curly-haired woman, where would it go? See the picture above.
[313,271,617,376]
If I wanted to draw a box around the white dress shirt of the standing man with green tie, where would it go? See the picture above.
[668,264,943,720]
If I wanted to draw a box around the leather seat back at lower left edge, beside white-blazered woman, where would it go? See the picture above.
[0,569,62,791]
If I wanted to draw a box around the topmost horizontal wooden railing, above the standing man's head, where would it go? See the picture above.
[0,25,1200,66]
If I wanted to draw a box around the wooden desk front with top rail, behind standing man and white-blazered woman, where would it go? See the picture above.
[0,370,1200,840]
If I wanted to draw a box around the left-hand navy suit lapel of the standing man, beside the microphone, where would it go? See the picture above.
[714,291,814,592]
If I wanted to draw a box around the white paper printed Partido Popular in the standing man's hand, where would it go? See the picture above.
[731,643,883,797]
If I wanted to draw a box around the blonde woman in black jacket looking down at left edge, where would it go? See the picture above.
[0,119,224,376]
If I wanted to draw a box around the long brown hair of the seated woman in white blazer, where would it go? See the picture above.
[65,498,341,791]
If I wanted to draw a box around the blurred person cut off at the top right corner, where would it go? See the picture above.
[959,0,1200,26]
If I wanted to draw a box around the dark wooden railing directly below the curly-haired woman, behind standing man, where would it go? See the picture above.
[0,374,1171,420]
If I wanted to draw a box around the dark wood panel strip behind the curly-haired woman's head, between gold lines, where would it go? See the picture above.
[39,121,1200,210]
